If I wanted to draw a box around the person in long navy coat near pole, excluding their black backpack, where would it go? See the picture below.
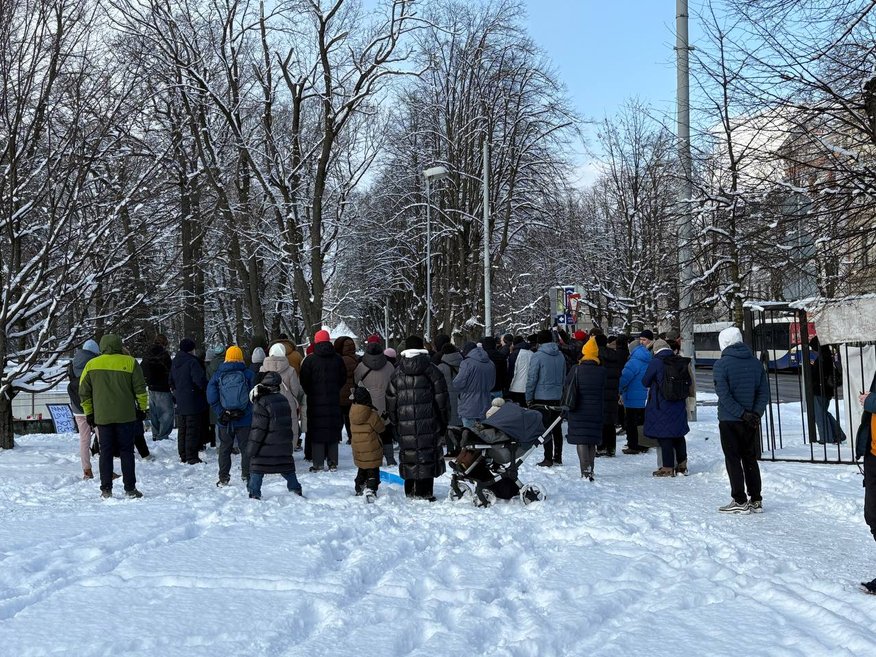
[642,340,690,477]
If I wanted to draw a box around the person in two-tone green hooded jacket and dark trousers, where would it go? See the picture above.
[79,333,149,498]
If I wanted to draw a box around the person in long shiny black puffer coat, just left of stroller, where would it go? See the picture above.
[386,336,450,501]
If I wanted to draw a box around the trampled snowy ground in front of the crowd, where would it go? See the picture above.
[0,404,876,657]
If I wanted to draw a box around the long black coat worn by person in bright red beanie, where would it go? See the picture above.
[301,342,347,445]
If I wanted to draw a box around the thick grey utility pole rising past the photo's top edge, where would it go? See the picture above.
[675,0,697,421]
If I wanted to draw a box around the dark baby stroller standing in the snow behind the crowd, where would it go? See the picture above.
[448,403,562,507]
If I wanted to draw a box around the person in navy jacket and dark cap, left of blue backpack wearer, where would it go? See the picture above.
[170,338,207,465]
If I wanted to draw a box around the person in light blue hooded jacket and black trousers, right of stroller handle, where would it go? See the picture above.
[526,330,566,468]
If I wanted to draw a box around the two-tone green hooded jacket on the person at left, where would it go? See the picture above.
[79,333,149,425]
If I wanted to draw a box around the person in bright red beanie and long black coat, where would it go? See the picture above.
[301,331,347,472]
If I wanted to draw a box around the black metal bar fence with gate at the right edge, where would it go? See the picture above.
[745,303,864,464]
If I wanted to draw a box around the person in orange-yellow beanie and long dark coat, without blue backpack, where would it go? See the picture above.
[566,338,614,481]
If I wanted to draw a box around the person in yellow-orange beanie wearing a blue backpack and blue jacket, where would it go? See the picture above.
[207,345,255,486]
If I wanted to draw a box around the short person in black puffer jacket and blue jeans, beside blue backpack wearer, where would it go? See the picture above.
[246,372,301,500]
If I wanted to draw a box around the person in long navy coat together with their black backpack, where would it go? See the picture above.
[642,340,691,477]
